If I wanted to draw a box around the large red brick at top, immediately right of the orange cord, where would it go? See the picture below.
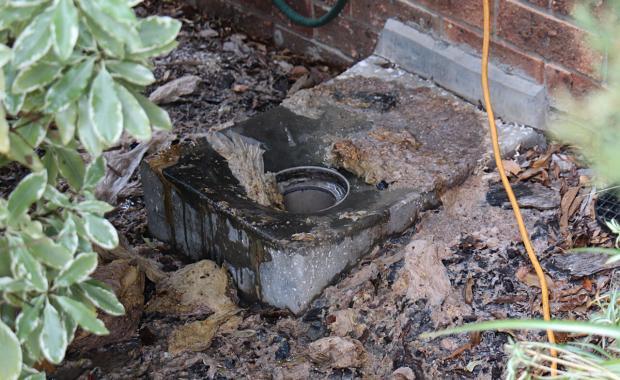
[497,0,602,77]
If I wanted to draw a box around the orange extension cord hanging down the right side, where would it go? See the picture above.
[482,0,557,376]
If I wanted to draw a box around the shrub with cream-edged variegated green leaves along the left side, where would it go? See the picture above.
[0,0,180,379]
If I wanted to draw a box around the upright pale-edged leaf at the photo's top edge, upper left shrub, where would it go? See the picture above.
[52,0,79,61]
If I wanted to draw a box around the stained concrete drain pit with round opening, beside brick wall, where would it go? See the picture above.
[141,56,486,313]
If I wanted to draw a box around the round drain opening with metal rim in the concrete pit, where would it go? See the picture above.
[276,166,349,214]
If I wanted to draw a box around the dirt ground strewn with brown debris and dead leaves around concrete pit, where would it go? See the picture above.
[49,1,614,379]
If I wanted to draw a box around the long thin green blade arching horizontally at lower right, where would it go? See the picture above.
[420,319,620,339]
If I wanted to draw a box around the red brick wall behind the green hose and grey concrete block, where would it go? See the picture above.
[190,0,605,99]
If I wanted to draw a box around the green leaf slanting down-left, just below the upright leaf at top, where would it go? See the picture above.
[45,58,95,113]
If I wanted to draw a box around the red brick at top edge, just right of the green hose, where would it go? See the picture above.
[352,0,439,31]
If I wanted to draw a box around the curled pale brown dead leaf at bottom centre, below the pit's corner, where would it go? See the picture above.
[308,336,366,368]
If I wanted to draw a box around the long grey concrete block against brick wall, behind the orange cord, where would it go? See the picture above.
[375,19,549,129]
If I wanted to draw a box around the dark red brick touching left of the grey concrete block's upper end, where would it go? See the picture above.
[316,17,378,59]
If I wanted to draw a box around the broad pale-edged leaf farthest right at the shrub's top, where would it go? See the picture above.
[132,16,181,53]
